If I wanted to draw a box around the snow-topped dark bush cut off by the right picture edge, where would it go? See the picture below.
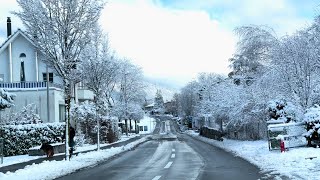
[303,105,320,146]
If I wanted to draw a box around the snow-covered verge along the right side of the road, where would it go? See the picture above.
[186,131,320,179]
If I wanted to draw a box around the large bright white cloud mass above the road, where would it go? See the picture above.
[102,1,234,88]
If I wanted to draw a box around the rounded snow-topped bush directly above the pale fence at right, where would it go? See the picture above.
[267,99,299,123]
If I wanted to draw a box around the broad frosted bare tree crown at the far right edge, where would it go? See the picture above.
[273,31,320,108]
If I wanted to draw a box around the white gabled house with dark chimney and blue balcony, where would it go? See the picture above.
[0,17,93,122]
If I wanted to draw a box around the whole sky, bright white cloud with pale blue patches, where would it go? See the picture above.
[0,0,320,88]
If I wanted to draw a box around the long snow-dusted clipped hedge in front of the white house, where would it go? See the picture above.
[0,123,65,156]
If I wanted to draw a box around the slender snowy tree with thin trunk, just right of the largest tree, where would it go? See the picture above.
[79,29,120,150]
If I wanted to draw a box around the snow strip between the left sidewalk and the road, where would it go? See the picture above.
[0,136,149,180]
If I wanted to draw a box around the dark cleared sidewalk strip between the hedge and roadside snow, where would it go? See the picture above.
[0,135,143,173]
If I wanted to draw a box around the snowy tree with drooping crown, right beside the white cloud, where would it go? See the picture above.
[229,25,278,85]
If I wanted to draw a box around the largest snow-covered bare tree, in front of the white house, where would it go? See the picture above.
[14,0,104,159]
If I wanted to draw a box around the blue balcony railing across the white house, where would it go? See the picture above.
[0,81,63,89]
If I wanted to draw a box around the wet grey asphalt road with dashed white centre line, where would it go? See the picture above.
[59,120,265,180]
